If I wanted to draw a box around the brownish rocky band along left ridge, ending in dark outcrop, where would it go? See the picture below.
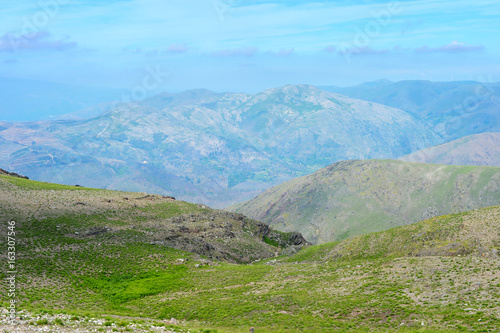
[0,172,307,263]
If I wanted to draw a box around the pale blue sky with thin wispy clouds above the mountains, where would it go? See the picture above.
[0,0,500,93]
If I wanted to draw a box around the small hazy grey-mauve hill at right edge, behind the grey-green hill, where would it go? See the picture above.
[400,133,500,166]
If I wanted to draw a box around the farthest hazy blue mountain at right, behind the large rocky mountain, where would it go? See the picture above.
[322,80,500,142]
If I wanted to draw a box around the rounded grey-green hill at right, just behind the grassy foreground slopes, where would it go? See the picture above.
[228,160,500,244]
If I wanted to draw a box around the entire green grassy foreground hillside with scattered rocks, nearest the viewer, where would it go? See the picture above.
[0,171,500,333]
